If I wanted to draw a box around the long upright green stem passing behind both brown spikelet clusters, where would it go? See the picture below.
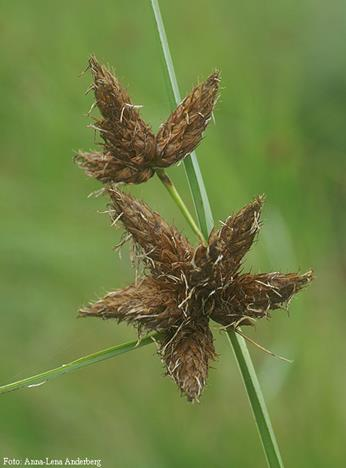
[151,0,283,468]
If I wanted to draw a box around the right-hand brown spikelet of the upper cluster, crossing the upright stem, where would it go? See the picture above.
[156,72,220,167]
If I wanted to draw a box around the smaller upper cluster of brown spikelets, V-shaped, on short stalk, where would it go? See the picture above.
[75,57,220,184]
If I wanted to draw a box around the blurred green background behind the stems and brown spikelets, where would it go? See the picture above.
[0,0,346,468]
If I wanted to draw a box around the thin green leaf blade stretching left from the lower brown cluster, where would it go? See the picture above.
[0,333,158,395]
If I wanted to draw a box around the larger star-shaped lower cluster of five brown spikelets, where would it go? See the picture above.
[80,187,312,401]
